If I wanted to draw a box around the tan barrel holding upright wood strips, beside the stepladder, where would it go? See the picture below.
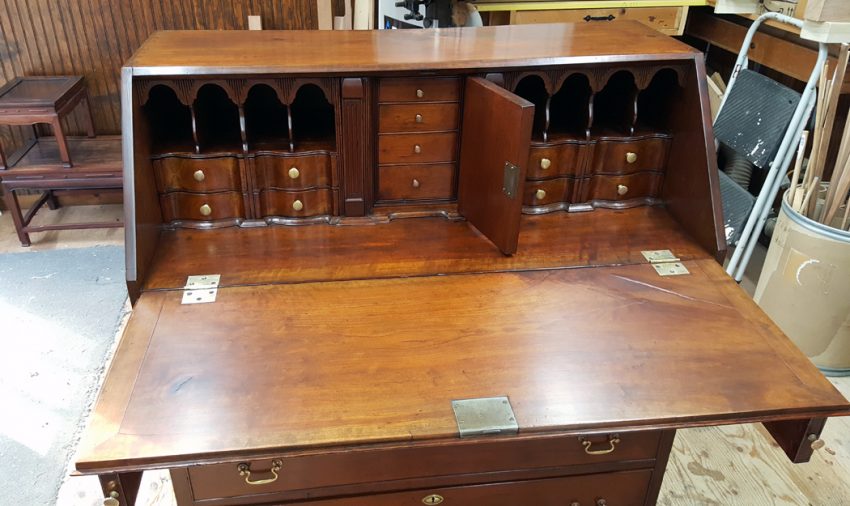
[754,194,850,376]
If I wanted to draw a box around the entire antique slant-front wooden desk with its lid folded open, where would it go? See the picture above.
[76,23,850,506]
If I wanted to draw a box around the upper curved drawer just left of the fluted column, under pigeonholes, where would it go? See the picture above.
[254,153,333,189]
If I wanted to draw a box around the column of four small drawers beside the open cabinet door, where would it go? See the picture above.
[376,78,460,202]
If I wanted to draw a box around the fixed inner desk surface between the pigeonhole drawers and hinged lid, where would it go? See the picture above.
[145,206,706,290]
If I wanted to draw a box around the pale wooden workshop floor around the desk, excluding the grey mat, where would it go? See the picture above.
[0,206,850,506]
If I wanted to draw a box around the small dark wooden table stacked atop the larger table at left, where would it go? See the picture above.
[0,76,94,169]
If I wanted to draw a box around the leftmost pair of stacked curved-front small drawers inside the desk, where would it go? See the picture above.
[153,156,247,223]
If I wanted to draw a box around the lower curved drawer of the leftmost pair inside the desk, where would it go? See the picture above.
[159,192,245,222]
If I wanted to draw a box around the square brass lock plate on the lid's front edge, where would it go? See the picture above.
[452,397,519,438]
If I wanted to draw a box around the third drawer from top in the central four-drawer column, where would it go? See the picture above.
[378,132,457,164]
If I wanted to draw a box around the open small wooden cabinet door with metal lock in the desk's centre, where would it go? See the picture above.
[458,77,534,255]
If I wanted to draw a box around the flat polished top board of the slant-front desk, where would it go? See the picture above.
[126,23,697,76]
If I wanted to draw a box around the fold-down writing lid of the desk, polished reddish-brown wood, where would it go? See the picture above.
[77,258,848,470]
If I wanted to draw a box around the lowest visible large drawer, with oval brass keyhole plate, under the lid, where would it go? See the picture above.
[295,469,652,506]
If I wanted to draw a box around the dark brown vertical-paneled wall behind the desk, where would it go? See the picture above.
[0,0,318,153]
